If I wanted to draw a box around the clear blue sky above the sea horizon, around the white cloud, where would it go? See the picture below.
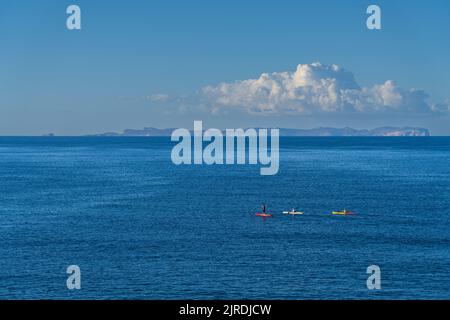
[0,0,450,135]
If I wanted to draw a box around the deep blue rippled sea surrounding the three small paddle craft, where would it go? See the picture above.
[0,137,450,299]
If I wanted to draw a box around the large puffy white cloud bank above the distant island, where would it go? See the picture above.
[201,62,450,115]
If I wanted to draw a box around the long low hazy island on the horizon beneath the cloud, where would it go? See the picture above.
[91,127,430,137]
